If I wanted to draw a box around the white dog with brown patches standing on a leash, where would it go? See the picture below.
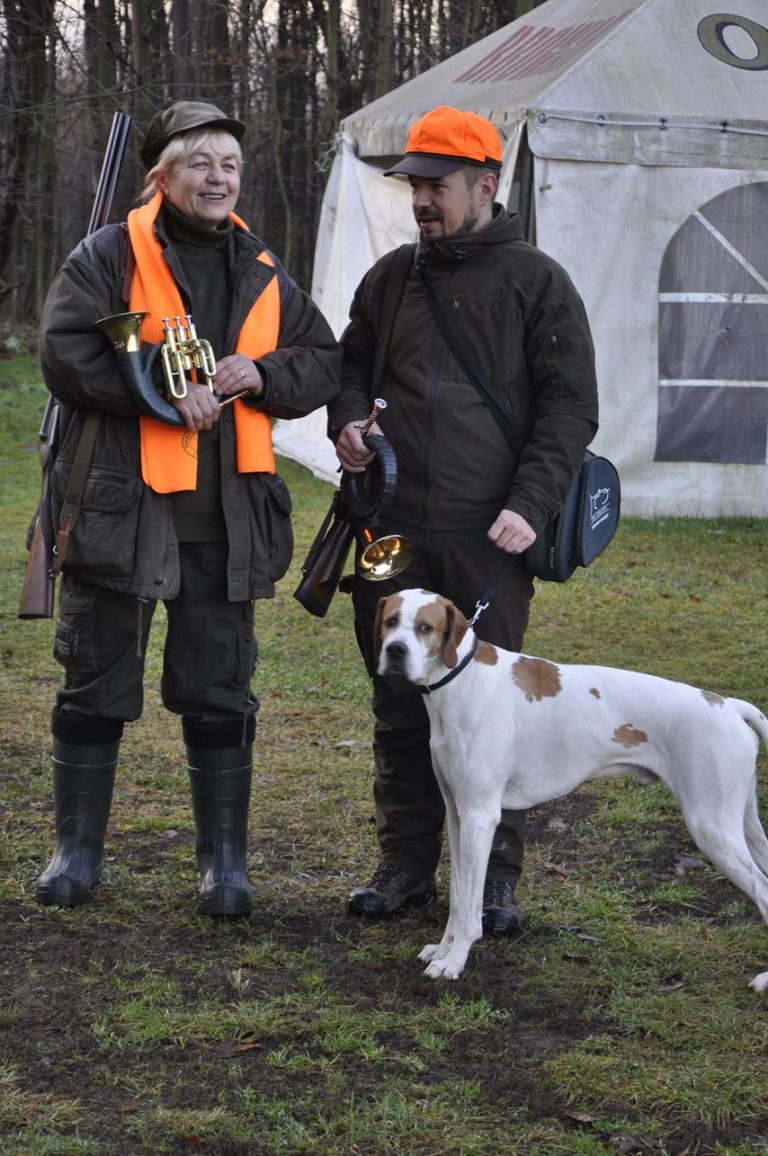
[376,590,768,992]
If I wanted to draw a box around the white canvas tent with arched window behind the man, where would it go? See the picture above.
[271,0,768,518]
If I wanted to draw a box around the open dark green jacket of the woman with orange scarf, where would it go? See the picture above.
[40,211,341,601]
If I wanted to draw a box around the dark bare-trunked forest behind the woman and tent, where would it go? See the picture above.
[0,0,541,332]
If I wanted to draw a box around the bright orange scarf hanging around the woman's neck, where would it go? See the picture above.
[127,193,280,494]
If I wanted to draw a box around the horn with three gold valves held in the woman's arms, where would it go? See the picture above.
[96,313,248,427]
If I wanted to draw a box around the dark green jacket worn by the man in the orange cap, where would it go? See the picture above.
[328,205,598,533]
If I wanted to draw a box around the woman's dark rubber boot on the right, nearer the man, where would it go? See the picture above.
[186,746,253,917]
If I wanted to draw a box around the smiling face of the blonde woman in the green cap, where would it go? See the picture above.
[156,145,239,229]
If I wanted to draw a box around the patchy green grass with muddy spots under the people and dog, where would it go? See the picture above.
[0,355,768,1156]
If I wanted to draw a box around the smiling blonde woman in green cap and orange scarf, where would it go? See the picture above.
[36,101,340,916]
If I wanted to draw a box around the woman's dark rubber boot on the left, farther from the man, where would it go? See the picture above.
[35,738,120,907]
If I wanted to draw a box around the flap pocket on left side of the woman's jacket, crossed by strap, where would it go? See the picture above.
[51,460,142,578]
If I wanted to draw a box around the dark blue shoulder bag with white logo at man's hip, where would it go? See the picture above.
[524,450,621,581]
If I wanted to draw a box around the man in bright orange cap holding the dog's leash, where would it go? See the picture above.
[328,99,598,935]
